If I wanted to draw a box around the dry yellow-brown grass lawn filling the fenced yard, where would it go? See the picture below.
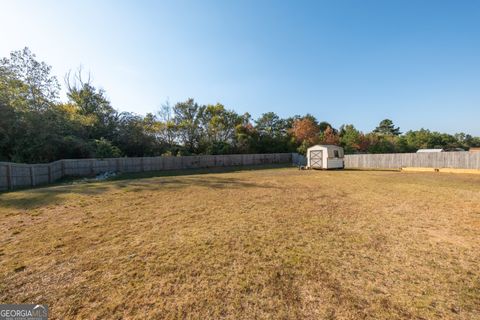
[0,168,480,319]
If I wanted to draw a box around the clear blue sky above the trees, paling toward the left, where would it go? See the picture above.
[0,0,480,135]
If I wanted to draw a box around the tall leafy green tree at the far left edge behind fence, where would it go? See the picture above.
[0,48,70,162]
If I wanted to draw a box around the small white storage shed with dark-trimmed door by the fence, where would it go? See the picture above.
[307,145,345,169]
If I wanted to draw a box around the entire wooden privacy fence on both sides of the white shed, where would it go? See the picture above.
[0,152,480,191]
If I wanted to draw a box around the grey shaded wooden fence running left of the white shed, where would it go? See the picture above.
[0,153,292,190]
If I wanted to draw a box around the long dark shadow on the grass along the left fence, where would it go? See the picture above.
[0,165,289,210]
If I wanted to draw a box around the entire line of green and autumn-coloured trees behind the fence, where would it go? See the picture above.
[0,48,480,163]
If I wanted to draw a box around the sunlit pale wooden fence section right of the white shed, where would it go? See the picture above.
[345,152,480,170]
